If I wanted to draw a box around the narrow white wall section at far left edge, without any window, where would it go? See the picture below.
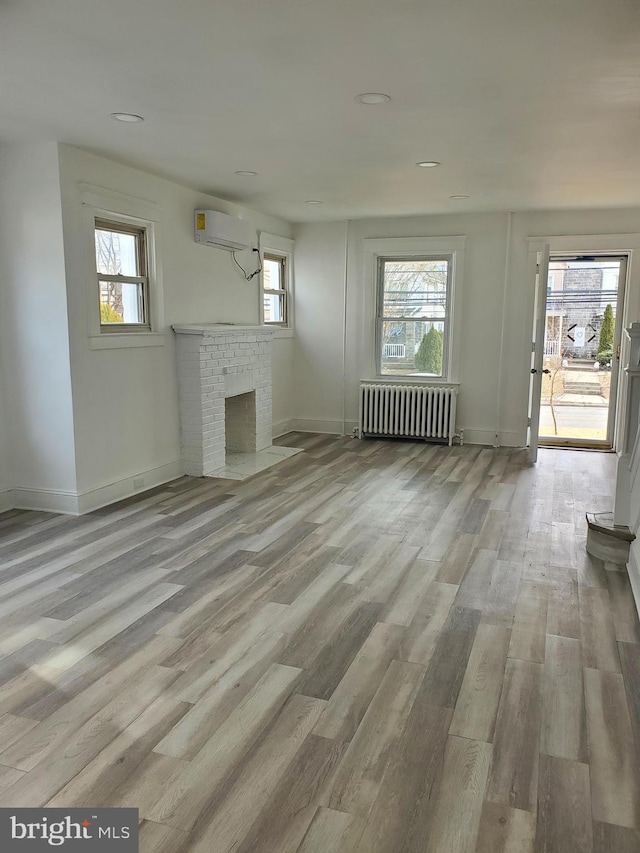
[0,142,76,508]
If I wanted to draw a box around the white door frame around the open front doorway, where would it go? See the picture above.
[527,233,640,452]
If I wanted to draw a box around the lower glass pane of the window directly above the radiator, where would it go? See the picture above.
[380,320,444,376]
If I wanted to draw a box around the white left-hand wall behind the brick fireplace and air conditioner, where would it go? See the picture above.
[60,145,292,506]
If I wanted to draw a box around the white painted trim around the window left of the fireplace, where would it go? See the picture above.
[80,184,165,350]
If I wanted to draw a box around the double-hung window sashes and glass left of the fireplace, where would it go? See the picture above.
[95,219,151,332]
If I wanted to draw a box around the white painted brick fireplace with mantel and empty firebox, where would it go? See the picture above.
[173,324,274,477]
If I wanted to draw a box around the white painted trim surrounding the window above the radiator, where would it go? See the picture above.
[362,236,466,385]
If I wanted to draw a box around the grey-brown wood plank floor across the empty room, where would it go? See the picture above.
[0,434,640,853]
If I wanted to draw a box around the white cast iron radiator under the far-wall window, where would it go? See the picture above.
[360,383,458,445]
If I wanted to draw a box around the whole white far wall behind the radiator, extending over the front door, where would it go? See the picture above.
[294,209,640,446]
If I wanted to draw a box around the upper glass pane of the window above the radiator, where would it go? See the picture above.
[382,259,449,319]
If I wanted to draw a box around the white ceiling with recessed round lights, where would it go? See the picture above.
[0,0,640,221]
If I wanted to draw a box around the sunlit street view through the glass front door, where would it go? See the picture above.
[539,255,626,448]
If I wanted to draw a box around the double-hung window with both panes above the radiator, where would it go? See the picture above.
[377,256,452,379]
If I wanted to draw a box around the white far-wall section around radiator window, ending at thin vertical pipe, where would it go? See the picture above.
[294,214,506,441]
